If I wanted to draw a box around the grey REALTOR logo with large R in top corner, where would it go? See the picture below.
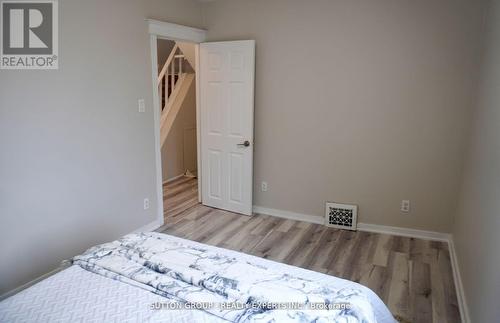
[0,0,58,69]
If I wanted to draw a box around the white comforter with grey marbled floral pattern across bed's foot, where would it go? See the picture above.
[73,232,376,322]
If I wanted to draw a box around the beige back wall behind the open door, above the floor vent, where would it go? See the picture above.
[203,0,482,232]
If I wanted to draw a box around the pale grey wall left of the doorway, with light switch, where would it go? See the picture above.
[0,0,201,294]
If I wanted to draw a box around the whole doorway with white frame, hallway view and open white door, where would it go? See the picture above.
[148,19,255,226]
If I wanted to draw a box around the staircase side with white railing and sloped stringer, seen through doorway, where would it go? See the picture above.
[157,42,195,146]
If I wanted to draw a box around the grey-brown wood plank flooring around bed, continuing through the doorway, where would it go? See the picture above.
[160,178,460,323]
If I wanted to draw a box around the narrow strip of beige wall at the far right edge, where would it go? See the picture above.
[453,0,500,322]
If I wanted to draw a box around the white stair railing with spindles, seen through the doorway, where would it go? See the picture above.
[157,44,185,111]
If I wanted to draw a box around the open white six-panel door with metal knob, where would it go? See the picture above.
[200,40,255,215]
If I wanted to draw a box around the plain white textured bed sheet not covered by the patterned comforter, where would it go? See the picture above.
[0,266,223,323]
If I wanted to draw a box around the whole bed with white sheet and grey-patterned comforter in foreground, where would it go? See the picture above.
[0,232,395,323]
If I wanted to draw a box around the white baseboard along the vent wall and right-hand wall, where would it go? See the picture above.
[253,205,470,323]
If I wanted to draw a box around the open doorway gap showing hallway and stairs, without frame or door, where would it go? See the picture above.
[156,38,199,222]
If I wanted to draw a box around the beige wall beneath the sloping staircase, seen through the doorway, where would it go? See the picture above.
[161,78,197,181]
